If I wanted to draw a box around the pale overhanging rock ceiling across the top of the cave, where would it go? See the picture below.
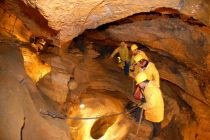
[2,0,210,45]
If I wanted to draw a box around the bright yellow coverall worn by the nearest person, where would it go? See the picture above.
[142,81,164,122]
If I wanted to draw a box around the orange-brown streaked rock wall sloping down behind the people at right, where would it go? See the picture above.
[85,15,210,139]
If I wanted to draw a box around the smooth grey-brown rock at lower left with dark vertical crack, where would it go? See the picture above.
[0,34,71,140]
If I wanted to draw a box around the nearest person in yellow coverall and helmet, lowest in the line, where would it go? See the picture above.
[135,72,164,136]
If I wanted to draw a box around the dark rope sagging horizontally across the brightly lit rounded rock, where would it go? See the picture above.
[39,105,139,120]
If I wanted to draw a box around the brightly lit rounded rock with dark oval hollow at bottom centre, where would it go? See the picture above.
[67,90,130,140]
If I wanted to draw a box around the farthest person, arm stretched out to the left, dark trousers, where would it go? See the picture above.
[110,42,129,75]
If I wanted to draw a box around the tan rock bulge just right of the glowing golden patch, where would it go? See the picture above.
[38,57,70,103]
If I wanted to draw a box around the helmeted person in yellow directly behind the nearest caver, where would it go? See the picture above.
[130,54,160,87]
